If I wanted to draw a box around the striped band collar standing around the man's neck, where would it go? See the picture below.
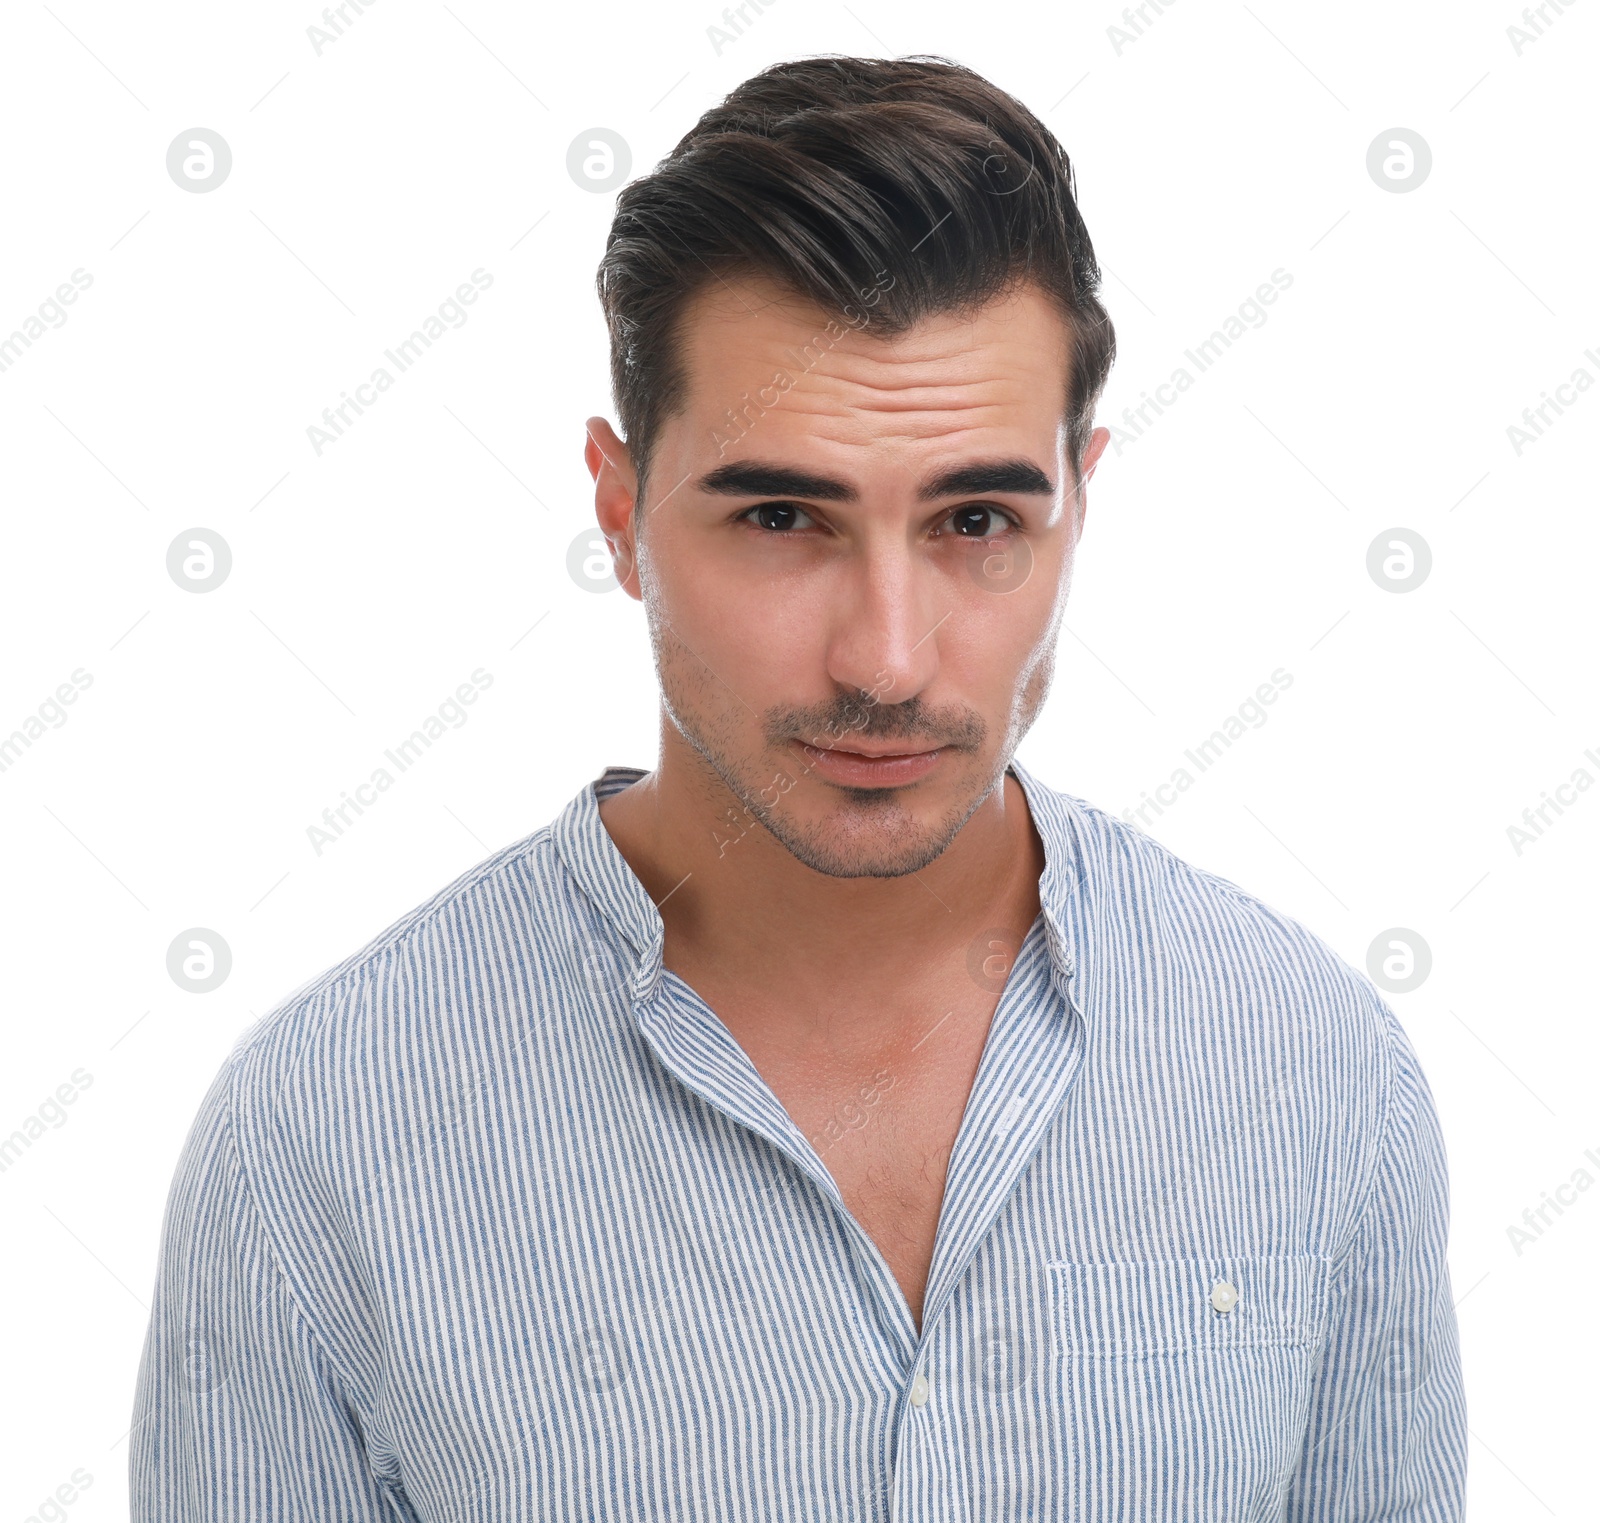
[550,758,1104,1016]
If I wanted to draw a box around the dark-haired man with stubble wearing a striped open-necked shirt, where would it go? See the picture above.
[133,59,1466,1523]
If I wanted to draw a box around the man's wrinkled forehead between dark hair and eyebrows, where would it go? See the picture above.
[678,278,1070,448]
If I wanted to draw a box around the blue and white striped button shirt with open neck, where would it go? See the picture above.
[131,763,1466,1523]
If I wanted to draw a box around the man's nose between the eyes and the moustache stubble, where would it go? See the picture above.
[827,536,954,704]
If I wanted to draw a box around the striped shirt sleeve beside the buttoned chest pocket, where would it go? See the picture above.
[1285,1000,1467,1523]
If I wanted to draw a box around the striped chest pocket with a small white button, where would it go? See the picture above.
[1050,1254,1330,1523]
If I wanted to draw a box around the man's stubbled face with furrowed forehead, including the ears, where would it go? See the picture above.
[589,267,1107,877]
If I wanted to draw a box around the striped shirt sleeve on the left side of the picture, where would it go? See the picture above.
[128,1062,405,1523]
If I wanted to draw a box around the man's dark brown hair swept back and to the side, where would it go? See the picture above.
[595,56,1117,501]
